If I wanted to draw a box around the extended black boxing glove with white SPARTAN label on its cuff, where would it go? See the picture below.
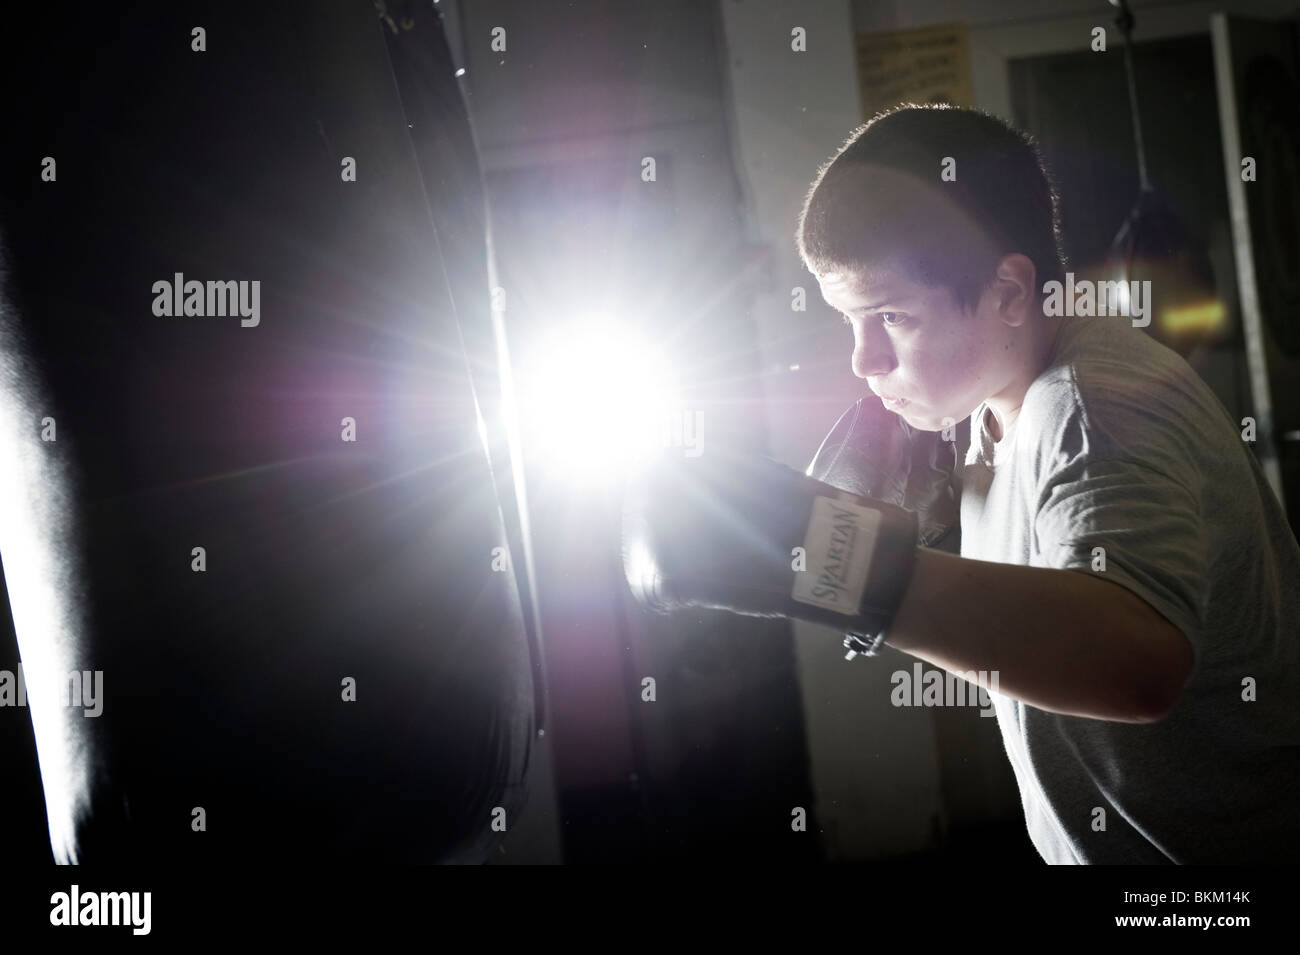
[623,452,918,638]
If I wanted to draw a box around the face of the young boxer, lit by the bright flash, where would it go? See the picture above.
[818,255,1032,431]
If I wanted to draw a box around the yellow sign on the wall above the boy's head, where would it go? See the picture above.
[857,23,975,120]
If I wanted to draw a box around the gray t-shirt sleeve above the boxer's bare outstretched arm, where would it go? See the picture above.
[1034,426,1206,665]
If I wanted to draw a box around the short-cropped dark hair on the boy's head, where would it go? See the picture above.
[794,103,1066,309]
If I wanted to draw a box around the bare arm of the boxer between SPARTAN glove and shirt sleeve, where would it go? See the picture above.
[887,548,1191,722]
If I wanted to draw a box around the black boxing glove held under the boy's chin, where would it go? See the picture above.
[805,394,970,554]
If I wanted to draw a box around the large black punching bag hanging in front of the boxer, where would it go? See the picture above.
[0,0,540,863]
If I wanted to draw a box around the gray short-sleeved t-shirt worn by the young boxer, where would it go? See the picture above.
[961,318,1300,864]
